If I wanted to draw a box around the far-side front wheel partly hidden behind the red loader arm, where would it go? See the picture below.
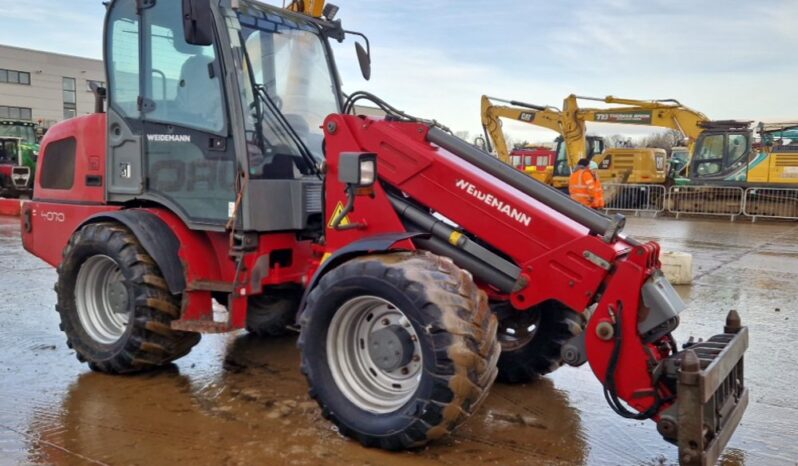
[491,301,584,383]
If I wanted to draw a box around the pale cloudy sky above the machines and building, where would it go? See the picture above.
[0,0,798,140]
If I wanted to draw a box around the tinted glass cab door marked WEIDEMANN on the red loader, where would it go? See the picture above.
[141,0,236,225]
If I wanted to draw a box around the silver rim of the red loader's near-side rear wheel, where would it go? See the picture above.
[75,255,130,345]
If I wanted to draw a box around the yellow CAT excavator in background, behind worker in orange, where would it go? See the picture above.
[482,96,667,189]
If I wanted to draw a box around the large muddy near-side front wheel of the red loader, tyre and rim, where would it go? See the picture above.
[299,252,500,450]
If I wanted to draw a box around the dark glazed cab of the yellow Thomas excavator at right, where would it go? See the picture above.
[690,122,753,181]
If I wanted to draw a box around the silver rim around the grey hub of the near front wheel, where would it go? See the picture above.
[327,296,424,414]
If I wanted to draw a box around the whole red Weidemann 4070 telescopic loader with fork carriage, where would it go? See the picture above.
[22,0,748,464]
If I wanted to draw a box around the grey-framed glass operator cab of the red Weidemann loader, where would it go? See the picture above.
[105,0,368,232]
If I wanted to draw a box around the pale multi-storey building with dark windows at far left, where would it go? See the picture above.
[0,45,105,127]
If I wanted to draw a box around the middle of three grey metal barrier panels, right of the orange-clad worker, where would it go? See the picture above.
[666,186,745,219]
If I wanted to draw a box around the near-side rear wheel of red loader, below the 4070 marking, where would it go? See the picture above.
[55,222,200,374]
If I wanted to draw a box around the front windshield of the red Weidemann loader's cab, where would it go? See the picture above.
[239,5,339,172]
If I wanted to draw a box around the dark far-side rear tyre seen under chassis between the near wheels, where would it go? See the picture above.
[247,290,302,337]
